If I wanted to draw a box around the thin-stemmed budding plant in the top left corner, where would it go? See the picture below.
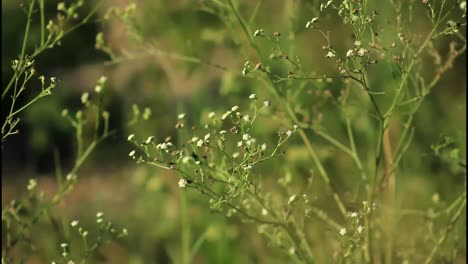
[2,0,105,145]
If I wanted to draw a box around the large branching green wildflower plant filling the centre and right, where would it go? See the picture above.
[114,0,466,263]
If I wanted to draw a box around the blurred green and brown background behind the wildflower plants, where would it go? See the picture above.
[2,0,466,263]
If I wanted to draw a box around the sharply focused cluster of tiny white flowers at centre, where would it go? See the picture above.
[127,94,298,210]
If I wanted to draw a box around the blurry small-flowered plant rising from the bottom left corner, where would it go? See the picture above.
[2,76,127,263]
